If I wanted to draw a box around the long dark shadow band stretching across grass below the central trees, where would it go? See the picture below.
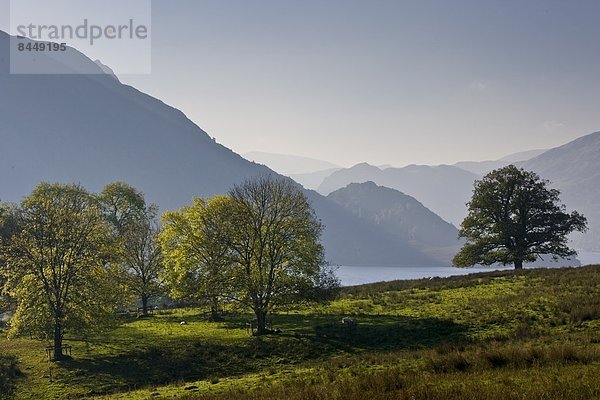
[61,315,465,394]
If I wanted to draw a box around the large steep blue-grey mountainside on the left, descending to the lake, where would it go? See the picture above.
[0,31,440,265]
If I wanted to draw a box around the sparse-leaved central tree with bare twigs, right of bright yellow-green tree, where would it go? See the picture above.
[224,176,337,334]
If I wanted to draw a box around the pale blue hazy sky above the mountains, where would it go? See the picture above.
[0,0,600,166]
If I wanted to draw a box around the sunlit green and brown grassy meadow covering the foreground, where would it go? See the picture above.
[0,266,600,400]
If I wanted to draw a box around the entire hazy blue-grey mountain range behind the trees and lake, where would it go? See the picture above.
[0,28,600,266]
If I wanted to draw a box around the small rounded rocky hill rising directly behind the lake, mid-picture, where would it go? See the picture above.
[327,182,461,264]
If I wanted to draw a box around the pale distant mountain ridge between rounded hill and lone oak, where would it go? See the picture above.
[318,164,479,226]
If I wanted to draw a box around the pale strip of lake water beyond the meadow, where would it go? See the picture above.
[336,252,600,286]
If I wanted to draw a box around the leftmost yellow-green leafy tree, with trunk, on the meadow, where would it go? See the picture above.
[2,183,116,358]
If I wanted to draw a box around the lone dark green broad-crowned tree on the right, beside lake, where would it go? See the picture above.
[453,165,586,269]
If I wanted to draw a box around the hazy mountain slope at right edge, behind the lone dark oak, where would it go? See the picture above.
[519,132,600,251]
